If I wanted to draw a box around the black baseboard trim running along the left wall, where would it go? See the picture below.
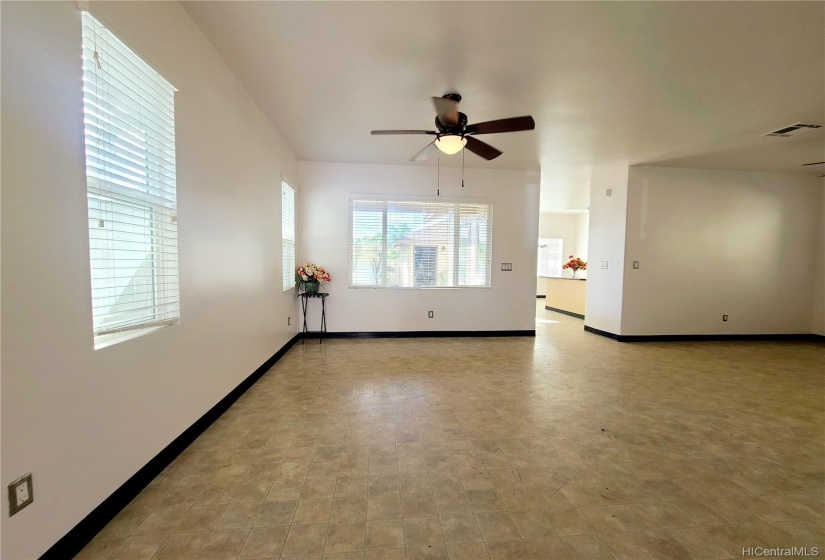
[40,333,301,560]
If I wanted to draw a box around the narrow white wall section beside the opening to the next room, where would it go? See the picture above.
[584,166,628,334]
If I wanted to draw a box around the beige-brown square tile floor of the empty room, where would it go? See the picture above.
[77,306,825,560]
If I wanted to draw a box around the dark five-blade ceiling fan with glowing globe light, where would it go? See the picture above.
[370,93,536,161]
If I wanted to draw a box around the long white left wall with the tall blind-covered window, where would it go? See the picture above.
[1,2,297,559]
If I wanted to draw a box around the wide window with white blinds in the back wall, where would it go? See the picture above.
[349,198,493,288]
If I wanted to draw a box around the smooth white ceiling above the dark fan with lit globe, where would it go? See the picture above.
[183,1,825,211]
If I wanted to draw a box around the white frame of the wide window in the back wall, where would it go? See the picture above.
[347,194,494,290]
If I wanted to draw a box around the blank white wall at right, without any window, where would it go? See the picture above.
[620,167,823,335]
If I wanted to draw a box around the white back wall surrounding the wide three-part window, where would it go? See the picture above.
[298,161,539,332]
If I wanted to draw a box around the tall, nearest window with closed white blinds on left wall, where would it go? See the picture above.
[83,12,180,347]
